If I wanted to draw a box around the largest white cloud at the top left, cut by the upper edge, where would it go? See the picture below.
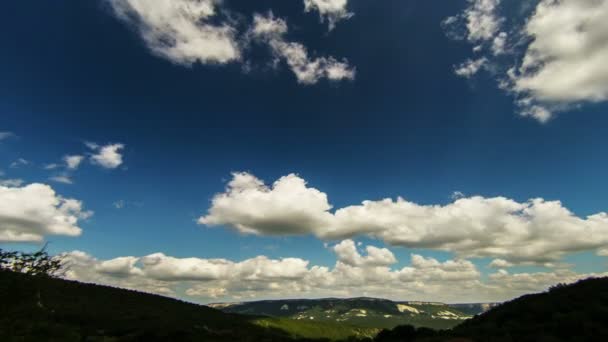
[108,0,241,65]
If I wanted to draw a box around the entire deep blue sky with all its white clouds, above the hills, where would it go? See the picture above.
[0,0,608,303]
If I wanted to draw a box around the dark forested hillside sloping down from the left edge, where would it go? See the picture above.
[0,271,318,342]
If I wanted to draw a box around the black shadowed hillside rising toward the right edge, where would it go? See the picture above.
[376,278,608,342]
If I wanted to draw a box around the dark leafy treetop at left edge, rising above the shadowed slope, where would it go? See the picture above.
[0,245,65,277]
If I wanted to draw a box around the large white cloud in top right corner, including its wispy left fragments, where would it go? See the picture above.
[444,0,608,122]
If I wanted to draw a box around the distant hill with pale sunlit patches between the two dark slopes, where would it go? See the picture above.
[209,297,472,329]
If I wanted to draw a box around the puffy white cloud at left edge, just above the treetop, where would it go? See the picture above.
[0,183,92,242]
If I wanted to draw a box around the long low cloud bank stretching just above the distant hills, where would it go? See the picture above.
[64,240,601,302]
